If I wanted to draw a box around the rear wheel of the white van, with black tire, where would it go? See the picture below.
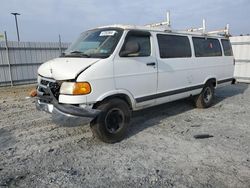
[194,82,214,108]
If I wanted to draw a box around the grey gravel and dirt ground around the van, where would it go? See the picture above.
[0,84,250,187]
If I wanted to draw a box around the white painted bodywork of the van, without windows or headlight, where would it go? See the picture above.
[38,25,234,110]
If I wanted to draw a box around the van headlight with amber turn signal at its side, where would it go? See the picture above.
[60,82,91,95]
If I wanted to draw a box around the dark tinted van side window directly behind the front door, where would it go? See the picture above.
[157,34,191,58]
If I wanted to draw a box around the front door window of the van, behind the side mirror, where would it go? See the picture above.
[120,30,151,57]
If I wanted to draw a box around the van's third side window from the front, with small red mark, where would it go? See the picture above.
[193,37,222,57]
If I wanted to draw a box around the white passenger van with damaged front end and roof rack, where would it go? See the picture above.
[36,25,234,143]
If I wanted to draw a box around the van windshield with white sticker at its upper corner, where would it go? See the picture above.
[62,28,123,58]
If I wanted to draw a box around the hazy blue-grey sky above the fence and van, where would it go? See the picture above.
[0,0,250,42]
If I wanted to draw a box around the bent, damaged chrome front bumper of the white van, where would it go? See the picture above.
[36,99,100,126]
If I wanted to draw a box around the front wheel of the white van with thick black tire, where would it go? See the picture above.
[90,98,131,143]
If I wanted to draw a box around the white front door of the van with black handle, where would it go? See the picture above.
[113,31,157,108]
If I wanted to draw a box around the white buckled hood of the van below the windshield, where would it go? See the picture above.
[38,57,100,80]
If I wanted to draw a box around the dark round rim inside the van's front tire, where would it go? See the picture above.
[105,108,124,133]
